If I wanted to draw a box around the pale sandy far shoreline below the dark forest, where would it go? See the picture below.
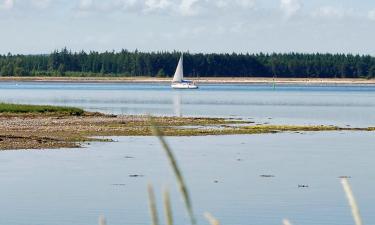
[0,77,375,85]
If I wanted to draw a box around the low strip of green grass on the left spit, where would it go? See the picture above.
[0,103,84,116]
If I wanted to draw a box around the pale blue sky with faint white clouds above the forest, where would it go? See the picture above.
[0,0,375,56]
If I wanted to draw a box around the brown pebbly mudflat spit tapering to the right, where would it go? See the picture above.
[0,112,375,150]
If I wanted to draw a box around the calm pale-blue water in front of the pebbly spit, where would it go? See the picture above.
[0,132,375,225]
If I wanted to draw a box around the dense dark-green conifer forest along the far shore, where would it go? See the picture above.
[0,48,375,78]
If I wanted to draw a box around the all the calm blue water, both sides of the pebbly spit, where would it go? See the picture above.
[0,82,375,225]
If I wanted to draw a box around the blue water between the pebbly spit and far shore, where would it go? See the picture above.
[0,82,375,127]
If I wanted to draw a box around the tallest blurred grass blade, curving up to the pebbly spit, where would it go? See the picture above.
[150,117,196,225]
